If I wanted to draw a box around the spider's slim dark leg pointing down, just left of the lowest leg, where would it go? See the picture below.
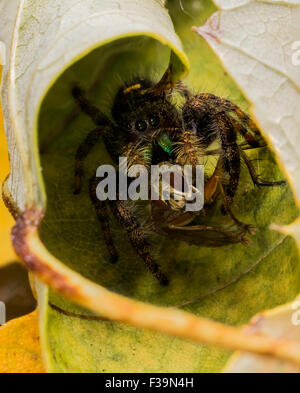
[90,177,119,263]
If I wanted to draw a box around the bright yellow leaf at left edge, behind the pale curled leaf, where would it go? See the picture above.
[0,68,17,267]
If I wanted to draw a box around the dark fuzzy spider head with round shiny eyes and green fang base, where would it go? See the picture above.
[111,79,182,166]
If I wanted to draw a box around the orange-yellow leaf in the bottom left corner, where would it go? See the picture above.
[0,311,44,373]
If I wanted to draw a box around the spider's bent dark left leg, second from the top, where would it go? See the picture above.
[74,127,107,194]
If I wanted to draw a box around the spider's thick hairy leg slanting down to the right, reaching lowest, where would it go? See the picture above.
[109,200,168,285]
